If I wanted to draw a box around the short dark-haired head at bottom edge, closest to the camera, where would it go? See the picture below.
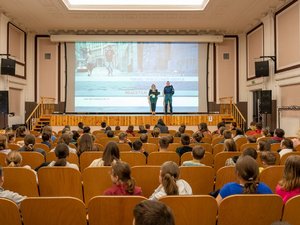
[133,200,175,225]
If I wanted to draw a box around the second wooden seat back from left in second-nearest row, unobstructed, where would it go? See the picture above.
[38,167,83,200]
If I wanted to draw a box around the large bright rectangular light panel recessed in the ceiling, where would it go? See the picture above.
[62,0,209,11]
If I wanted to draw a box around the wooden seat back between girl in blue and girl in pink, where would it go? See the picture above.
[259,166,284,193]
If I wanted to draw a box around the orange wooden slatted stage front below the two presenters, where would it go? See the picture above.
[49,114,230,126]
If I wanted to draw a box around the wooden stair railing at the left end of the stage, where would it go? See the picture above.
[25,97,55,130]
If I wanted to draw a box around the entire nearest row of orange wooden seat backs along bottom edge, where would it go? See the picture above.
[0,194,300,225]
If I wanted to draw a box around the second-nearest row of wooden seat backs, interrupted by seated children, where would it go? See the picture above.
[3,166,284,203]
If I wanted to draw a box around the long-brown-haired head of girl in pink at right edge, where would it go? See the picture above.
[279,155,300,191]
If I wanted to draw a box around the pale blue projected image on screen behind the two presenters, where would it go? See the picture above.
[75,42,199,113]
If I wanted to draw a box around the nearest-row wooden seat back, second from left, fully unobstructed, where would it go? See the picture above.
[21,197,87,225]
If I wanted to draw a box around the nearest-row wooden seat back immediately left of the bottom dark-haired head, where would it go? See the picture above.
[88,196,146,225]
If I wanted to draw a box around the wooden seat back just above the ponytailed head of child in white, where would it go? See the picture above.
[147,152,180,166]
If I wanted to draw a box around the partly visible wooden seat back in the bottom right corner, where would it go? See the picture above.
[282,195,300,225]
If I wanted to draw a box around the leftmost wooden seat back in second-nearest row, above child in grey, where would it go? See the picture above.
[3,167,39,197]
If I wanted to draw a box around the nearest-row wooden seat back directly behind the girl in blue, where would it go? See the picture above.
[218,194,283,225]
